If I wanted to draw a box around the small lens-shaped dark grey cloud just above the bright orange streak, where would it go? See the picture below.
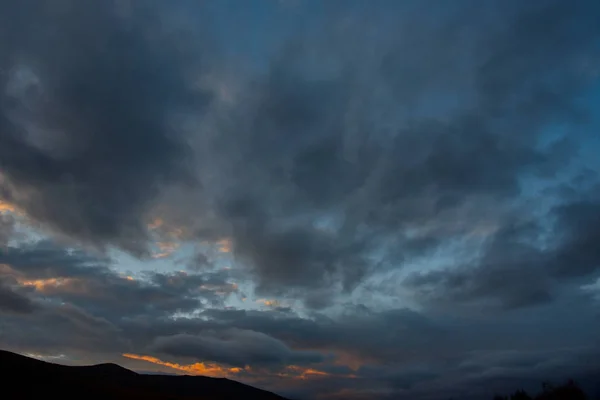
[152,329,323,368]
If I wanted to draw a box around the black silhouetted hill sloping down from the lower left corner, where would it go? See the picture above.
[0,350,286,400]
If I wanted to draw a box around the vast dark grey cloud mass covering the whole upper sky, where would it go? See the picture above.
[0,0,600,308]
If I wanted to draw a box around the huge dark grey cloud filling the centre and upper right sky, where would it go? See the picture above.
[183,2,600,307]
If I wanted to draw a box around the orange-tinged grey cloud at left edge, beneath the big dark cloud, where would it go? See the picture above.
[0,241,237,320]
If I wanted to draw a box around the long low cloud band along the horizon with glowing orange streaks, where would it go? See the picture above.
[2,260,600,398]
